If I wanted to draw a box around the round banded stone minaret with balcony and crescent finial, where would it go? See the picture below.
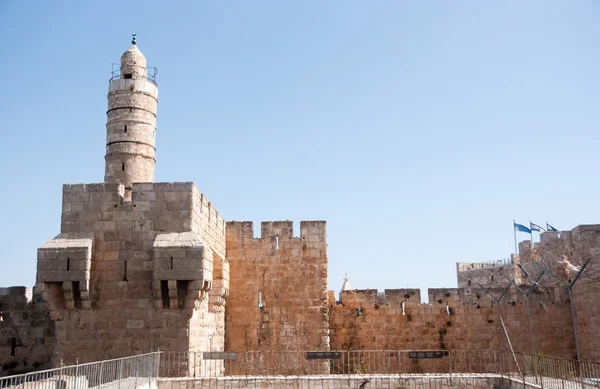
[104,35,158,192]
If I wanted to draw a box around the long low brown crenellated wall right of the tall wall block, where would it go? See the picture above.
[329,288,574,357]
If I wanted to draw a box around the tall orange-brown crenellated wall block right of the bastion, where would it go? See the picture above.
[225,221,329,352]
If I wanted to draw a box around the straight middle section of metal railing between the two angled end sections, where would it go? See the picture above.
[159,350,502,377]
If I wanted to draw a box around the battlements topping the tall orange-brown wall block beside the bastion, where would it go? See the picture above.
[226,220,327,242]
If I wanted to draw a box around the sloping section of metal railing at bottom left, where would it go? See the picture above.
[0,352,160,389]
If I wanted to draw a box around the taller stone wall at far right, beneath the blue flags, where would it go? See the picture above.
[457,225,600,360]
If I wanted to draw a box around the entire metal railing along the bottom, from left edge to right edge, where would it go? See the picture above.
[0,350,600,389]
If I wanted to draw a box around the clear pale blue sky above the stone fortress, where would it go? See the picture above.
[0,0,600,300]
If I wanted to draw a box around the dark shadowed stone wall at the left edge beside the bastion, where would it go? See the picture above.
[0,286,55,377]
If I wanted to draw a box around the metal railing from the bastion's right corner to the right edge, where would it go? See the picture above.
[159,350,600,382]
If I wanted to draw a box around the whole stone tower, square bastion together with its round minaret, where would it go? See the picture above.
[31,42,229,374]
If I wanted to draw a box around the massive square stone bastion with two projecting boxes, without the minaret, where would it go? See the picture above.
[36,183,228,365]
